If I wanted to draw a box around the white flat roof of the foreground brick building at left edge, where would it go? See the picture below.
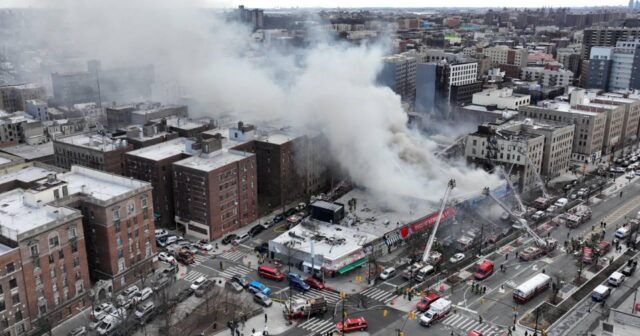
[0,189,76,241]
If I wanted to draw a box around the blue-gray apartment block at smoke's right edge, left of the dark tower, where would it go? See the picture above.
[378,53,418,104]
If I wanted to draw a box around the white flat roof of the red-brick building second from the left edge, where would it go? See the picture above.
[58,166,151,201]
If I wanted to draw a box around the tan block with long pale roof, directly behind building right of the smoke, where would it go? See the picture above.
[520,93,615,162]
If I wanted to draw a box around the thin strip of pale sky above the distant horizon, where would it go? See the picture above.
[0,0,629,8]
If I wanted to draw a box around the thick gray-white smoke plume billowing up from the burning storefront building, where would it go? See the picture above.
[18,0,499,202]
